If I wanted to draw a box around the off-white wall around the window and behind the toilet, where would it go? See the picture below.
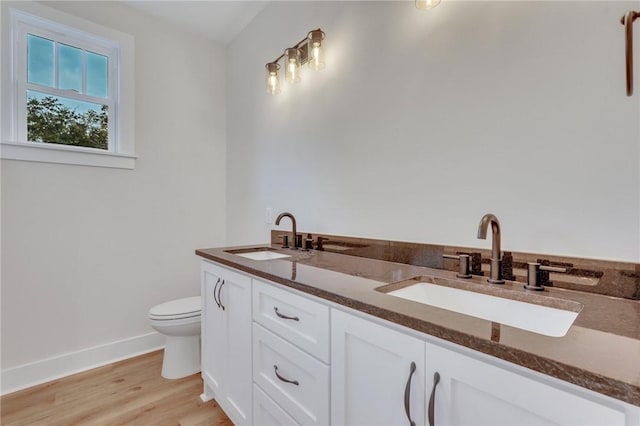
[1,2,226,390]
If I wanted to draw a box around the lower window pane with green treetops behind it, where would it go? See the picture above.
[27,90,109,149]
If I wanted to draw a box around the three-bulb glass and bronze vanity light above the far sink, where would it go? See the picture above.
[265,28,324,95]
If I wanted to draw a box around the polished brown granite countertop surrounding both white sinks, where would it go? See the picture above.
[196,245,640,406]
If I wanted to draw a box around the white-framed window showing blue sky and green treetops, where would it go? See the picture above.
[25,33,111,151]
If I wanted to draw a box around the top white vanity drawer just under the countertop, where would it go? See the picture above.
[253,279,329,364]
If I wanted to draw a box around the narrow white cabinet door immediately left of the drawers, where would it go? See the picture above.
[218,269,252,425]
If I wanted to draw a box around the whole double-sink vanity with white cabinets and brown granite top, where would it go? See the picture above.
[196,246,640,426]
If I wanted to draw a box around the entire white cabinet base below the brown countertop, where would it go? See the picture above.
[202,261,640,426]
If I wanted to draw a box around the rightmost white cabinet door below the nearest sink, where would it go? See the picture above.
[426,343,627,426]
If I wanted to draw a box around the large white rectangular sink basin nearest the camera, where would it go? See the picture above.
[387,282,579,337]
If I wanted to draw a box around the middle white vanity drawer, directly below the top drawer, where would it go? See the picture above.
[253,323,329,425]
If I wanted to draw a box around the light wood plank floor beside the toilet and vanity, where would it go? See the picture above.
[0,351,233,426]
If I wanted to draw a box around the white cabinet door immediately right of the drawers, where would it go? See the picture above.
[331,309,425,426]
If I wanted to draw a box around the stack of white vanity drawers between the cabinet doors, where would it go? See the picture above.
[253,279,330,426]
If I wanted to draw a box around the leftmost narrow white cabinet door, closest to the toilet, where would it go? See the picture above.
[201,261,226,400]
